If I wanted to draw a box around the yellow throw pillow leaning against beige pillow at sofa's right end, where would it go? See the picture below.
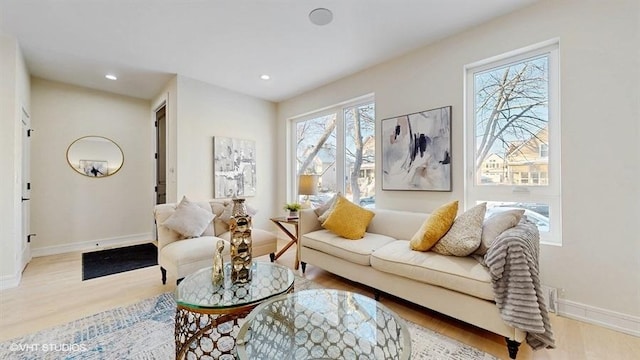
[409,200,458,251]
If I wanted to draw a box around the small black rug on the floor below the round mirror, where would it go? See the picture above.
[82,243,158,280]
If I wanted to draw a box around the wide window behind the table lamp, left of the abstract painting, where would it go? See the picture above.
[291,97,375,207]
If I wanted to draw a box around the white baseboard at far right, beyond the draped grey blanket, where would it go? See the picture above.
[558,299,640,337]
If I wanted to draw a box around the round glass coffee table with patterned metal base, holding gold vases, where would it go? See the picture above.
[175,261,294,360]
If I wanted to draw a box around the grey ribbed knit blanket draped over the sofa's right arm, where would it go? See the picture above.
[484,217,555,350]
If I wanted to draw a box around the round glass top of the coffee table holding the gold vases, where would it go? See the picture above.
[175,261,295,311]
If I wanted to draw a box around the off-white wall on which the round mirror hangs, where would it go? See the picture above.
[31,78,155,255]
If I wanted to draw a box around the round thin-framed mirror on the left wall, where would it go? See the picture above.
[67,136,124,177]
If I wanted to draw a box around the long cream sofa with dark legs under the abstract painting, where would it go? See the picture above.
[299,209,526,358]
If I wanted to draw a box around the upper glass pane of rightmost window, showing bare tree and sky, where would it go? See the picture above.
[474,55,549,185]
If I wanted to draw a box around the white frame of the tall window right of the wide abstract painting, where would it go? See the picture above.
[463,39,562,246]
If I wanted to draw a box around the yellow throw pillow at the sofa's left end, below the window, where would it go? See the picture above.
[322,196,375,240]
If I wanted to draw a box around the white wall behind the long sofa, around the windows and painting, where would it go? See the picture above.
[277,0,640,334]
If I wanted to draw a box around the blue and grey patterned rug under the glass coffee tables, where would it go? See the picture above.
[0,276,496,360]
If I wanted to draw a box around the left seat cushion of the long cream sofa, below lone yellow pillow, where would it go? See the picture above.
[301,230,395,266]
